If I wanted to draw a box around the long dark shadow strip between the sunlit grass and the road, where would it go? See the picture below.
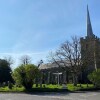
[23,88,100,96]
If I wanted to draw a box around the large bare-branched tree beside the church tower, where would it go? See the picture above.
[49,36,83,85]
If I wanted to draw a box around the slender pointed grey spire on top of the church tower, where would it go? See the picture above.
[87,5,93,37]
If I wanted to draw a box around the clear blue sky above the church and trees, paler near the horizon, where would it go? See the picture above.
[0,0,100,67]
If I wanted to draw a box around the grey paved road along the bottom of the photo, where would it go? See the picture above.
[0,92,100,100]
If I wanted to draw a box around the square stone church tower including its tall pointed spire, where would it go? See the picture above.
[80,6,100,72]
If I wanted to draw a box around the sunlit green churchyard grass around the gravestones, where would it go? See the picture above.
[0,84,94,92]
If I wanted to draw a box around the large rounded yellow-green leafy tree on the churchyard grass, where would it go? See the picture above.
[12,64,40,89]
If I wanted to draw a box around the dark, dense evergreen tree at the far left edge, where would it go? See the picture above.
[0,59,13,83]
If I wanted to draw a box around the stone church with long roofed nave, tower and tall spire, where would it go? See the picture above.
[39,6,100,84]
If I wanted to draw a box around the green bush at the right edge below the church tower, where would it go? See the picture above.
[88,69,100,87]
